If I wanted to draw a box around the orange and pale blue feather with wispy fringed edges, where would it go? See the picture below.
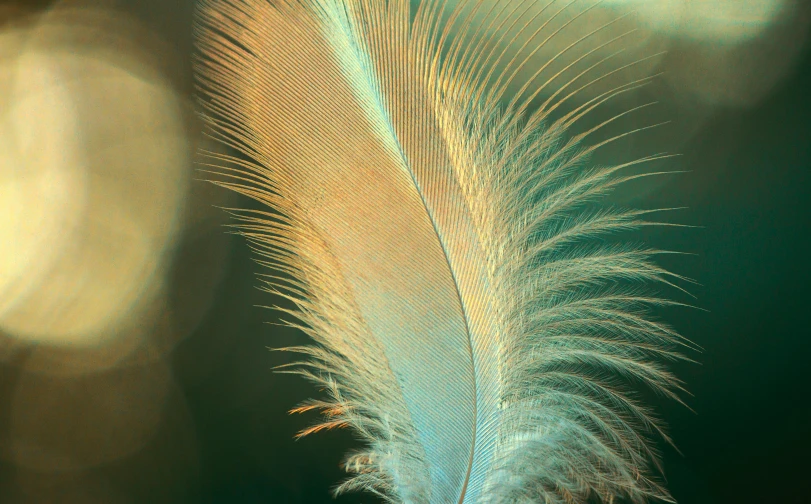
[196,0,689,504]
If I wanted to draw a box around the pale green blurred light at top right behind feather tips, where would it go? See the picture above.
[456,0,809,108]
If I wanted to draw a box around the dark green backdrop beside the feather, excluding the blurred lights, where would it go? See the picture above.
[0,0,811,504]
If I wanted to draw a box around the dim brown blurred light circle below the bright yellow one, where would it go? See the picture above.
[9,362,173,472]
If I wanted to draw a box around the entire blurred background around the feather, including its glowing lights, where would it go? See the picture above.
[0,0,811,504]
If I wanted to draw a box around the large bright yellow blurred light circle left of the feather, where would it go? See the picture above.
[0,4,190,346]
